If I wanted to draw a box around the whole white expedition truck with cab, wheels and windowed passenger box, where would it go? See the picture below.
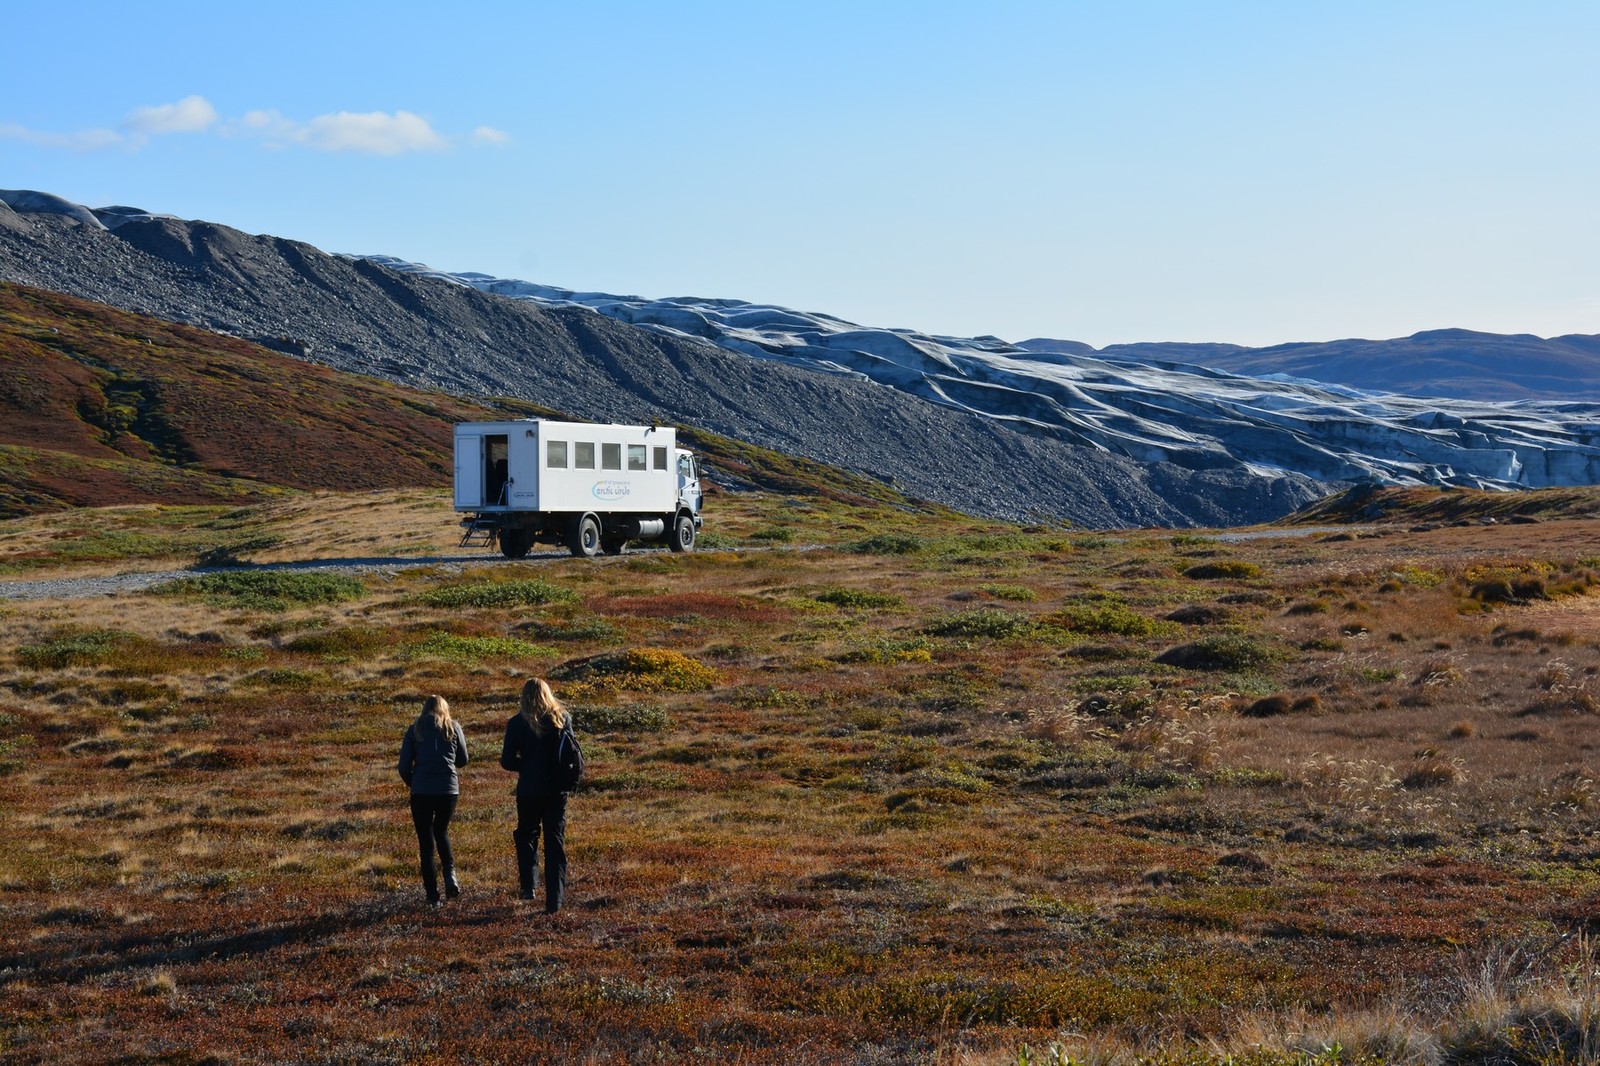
[456,418,702,559]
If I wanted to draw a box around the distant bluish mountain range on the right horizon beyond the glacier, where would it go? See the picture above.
[1018,330,1600,400]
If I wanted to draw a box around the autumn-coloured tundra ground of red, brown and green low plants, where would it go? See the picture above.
[0,474,1600,1064]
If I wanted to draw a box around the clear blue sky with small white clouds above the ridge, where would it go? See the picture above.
[0,0,1600,344]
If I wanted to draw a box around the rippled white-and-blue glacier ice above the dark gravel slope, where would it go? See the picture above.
[368,258,1600,488]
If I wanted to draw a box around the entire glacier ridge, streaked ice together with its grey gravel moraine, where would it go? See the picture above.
[0,190,1600,527]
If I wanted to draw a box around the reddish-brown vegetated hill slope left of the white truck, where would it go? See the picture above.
[0,285,508,515]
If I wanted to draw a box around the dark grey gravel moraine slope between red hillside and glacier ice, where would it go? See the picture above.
[0,192,1326,527]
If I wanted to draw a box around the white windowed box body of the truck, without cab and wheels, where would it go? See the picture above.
[454,419,678,514]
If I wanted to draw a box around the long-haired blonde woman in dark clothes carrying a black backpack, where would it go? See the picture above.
[501,677,582,914]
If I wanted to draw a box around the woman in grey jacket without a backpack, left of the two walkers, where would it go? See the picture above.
[400,696,467,908]
